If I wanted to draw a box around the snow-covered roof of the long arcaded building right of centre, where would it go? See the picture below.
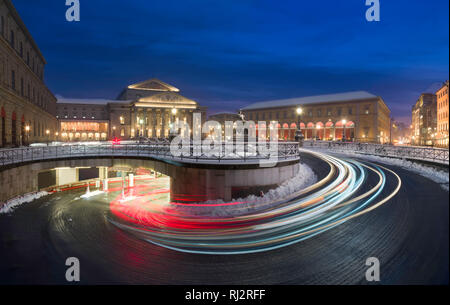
[241,91,378,110]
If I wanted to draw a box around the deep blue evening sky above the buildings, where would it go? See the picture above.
[13,0,449,122]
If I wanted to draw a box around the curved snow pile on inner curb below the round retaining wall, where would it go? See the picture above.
[168,164,317,217]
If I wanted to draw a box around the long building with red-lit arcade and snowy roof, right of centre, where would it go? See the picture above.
[241,91,391,143]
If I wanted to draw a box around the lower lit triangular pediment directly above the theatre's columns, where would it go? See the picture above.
[135,92,197,109]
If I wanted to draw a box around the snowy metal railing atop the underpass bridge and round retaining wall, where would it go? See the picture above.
[0,142,300,166]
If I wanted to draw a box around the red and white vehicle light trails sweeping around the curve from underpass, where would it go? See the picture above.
[110,152,401,254]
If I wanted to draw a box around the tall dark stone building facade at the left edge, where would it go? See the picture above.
[0,0,58,147]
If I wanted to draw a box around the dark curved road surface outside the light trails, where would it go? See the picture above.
[0,156,449,285]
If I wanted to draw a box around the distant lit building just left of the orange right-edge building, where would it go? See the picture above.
[411,93,437,146]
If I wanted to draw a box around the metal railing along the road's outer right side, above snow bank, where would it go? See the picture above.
[303,141,449,165]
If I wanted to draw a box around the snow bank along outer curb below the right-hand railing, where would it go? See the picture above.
[309,148,449,192]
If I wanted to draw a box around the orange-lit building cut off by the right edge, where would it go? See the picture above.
[436,81,449,148]
